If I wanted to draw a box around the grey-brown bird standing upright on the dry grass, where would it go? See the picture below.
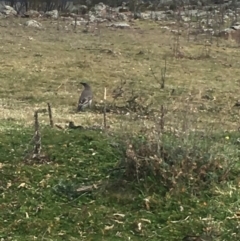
[77,82,93,111]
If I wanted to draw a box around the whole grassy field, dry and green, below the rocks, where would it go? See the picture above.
[0,19,240,241]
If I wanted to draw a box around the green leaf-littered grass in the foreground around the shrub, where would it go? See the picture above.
[0,122,240,241]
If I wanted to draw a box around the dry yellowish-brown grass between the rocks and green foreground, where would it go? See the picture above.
[0,19,240,130]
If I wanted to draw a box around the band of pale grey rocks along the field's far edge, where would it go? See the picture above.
[0,1,240,41]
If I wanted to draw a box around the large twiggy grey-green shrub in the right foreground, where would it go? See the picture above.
[121,129,233,191]
